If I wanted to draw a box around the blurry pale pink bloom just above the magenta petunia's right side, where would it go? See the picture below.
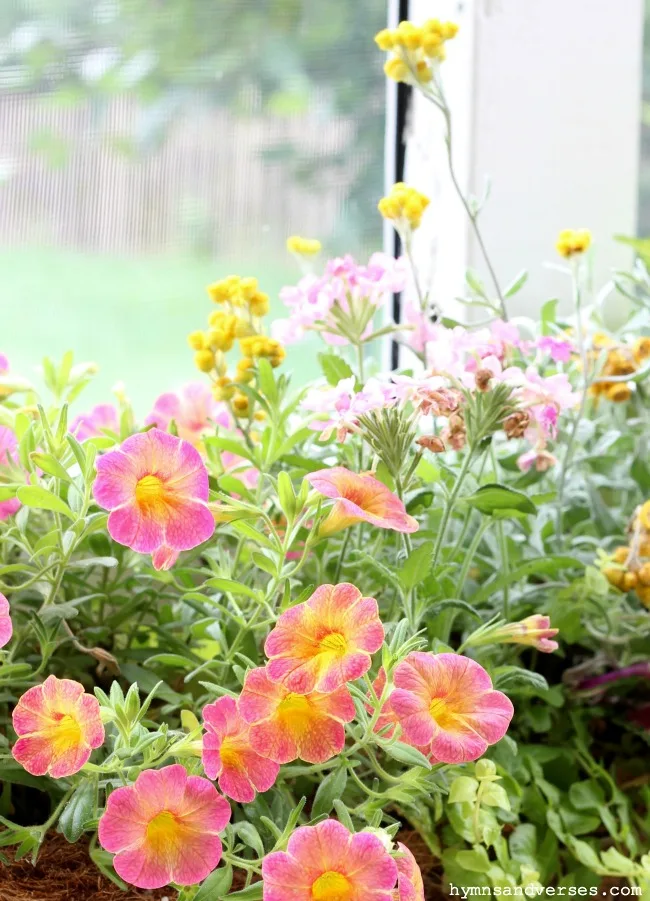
[145,382,231,447]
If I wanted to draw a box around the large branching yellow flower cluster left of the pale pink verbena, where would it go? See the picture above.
[188,275,285,419]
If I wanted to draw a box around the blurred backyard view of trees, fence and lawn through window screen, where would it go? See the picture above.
[0,0,386,414]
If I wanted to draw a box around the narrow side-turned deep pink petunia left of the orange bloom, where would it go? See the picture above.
[203,697,280,804]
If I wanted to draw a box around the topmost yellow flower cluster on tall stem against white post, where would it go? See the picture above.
[375,19,458,84]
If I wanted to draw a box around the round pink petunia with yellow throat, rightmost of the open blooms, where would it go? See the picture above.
[390,651,514,763]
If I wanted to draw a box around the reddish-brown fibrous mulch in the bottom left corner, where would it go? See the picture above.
[0,833,178,901]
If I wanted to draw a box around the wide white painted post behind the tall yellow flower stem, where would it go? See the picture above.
[407,0,644,318]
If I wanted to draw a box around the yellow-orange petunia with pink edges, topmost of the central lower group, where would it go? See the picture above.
[264,582,384,694]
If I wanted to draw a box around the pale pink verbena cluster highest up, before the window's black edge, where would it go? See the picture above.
[273,253,408,344]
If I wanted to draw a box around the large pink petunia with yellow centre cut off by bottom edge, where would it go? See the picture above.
[262,820,397,901]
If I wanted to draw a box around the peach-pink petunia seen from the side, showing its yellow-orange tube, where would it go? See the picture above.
[306,466,419,536]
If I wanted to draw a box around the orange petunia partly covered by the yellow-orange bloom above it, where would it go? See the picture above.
[239,667,355,764]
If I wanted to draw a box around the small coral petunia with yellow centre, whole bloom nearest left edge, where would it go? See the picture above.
[11,676,104,779]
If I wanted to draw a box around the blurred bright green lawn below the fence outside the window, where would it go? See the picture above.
[0,247,317,415]
